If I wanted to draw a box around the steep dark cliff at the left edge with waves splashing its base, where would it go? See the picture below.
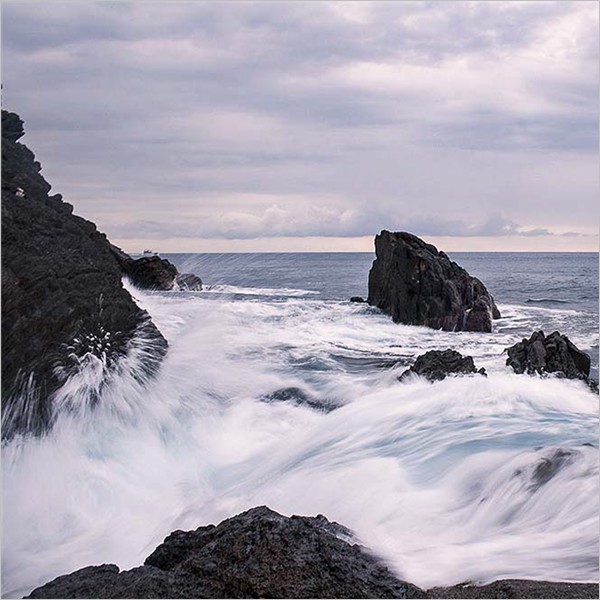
[2,111,167,437]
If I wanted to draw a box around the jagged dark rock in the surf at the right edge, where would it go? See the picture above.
[506,331,594,387]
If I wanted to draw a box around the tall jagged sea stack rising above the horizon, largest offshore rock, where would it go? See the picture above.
[368,231,500,332]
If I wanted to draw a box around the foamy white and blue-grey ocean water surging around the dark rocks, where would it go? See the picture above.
[2,254,599,597]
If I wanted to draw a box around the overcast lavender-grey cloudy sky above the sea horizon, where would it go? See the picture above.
[2,0,599,252]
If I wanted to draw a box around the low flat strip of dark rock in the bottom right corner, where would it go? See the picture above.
[427,579,598,598]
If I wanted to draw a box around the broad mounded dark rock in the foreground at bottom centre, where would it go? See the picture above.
[29,506,426,598]
